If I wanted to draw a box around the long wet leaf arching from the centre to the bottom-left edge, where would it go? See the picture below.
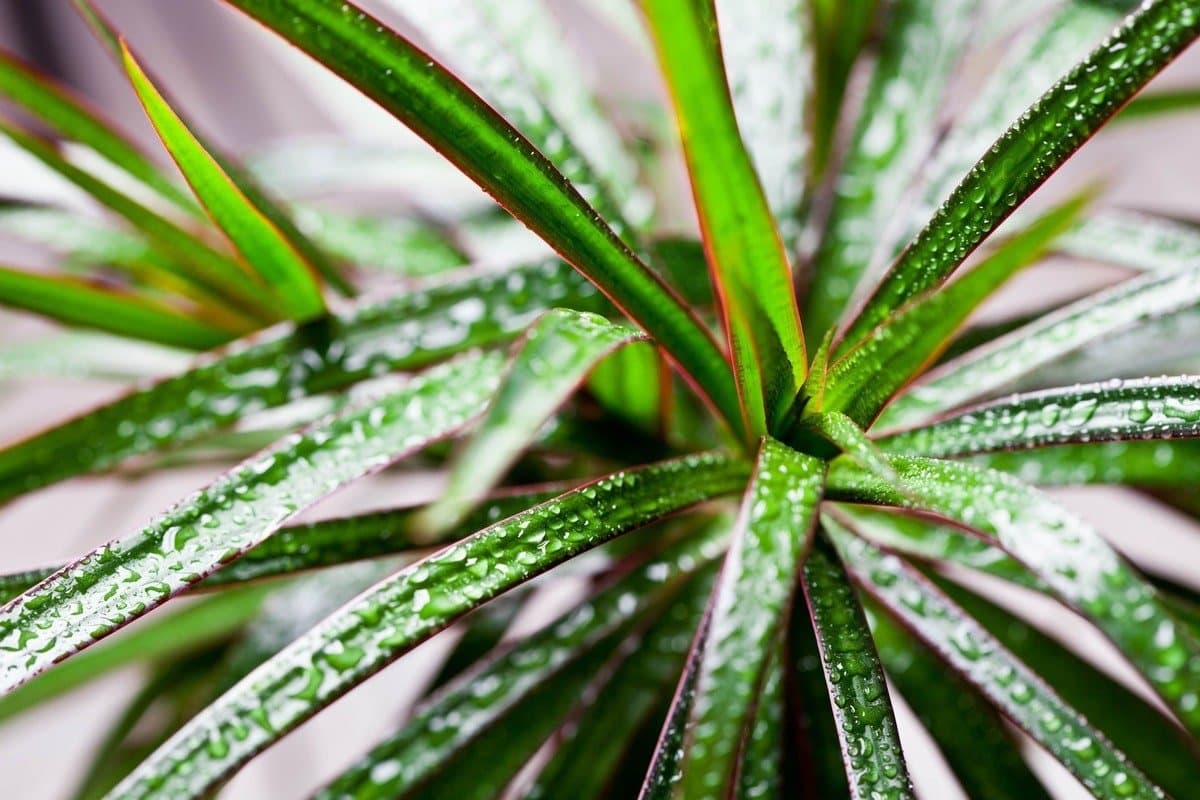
[113,455,746,799]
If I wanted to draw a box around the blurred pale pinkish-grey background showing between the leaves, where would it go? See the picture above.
[0,0,1200,800]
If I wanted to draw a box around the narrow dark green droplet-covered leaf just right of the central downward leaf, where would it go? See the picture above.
[800,536,914,800]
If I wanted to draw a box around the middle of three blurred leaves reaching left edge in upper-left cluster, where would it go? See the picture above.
[0,121,278,320]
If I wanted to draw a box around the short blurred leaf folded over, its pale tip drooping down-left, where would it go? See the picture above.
[425,309,642,530]
